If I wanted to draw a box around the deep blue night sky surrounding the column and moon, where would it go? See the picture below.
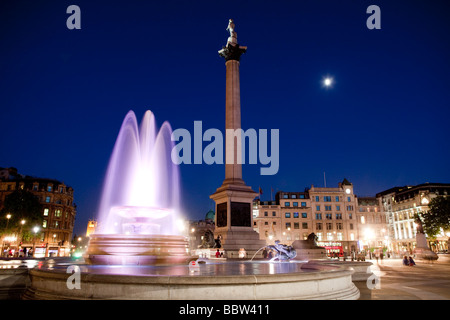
[0,0,450,233]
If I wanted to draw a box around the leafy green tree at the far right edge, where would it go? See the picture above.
[419,196,450,238]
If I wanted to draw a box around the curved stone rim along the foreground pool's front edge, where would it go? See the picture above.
[30,263,354,285]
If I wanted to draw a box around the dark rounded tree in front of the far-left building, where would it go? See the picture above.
[0,190,43,235]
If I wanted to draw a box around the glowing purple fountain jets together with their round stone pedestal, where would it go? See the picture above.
[85,111,191,265]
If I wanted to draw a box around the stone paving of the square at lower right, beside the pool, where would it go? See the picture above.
[362,254,450,300]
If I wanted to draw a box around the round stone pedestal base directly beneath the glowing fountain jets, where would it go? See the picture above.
[85,234,195,265]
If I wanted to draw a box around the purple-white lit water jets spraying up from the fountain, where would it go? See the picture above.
[96,111,180,235]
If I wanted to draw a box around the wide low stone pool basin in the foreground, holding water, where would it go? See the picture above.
[23,261,359,300]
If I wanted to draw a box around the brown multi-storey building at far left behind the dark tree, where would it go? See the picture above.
[0,169,76,257]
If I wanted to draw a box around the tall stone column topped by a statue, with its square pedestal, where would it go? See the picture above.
[210,19,266,258]
